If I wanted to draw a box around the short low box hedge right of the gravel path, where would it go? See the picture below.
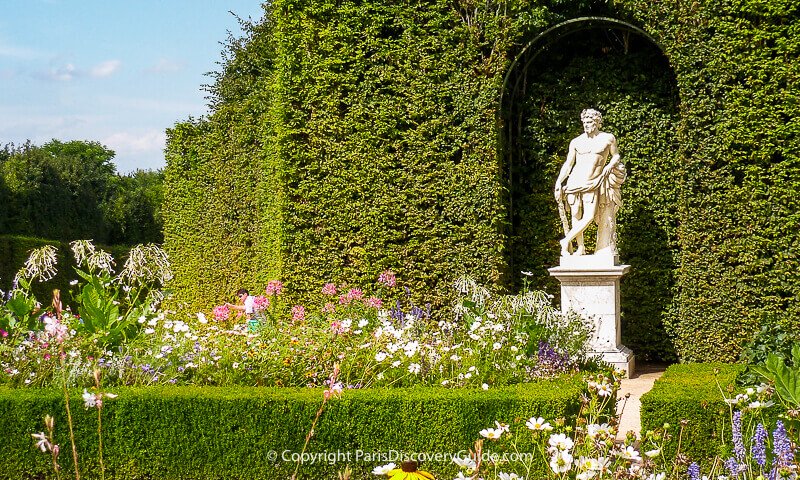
[640,363,744,462]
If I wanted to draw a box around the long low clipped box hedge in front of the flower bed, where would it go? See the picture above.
[0,377,585,480]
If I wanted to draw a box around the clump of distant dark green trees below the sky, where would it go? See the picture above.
[0,140,162,245]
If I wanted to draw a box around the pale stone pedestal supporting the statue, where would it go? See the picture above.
[549,254,634,377]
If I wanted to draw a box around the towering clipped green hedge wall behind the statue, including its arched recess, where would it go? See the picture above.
[165,0,800,361]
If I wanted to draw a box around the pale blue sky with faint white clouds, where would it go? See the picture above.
[0,0,262,173]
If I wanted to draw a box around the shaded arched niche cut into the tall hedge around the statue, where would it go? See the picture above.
[502,17,682,360]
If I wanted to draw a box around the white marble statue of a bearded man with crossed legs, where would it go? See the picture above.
[555,108,625,256]
